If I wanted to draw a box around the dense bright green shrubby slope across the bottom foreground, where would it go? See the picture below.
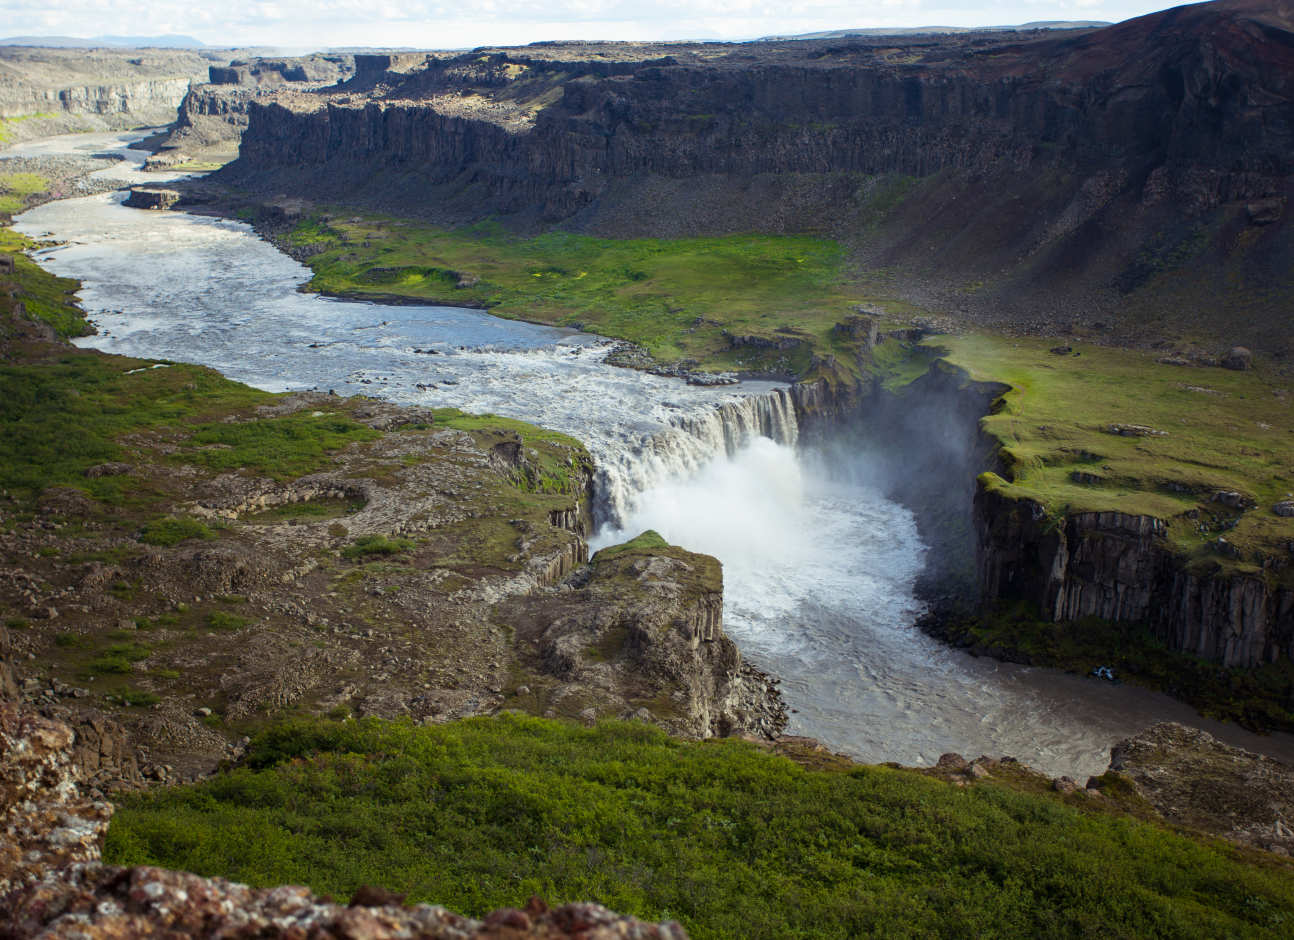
[105,715,1294,939]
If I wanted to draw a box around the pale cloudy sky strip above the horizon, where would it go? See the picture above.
[0,0,1190,49]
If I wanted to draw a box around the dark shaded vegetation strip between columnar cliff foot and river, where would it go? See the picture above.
[937,603,1294,732]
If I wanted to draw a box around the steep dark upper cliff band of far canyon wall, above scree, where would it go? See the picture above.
[235,4,1294,201]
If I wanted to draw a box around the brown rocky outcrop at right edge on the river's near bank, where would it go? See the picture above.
[1110,722,1294,855]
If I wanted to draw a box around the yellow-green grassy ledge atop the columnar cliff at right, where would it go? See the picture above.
[930,334,1294,577]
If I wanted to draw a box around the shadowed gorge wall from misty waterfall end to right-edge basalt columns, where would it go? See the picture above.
[791,317,1294,667]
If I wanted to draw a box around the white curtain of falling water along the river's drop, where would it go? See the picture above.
[594,388,800,530]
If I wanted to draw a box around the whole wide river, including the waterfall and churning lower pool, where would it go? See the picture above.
[12,135,1294,779]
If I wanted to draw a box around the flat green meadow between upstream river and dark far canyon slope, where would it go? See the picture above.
[287,218,879,373]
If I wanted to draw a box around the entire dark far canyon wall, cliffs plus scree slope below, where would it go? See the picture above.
[228,0,1294,348]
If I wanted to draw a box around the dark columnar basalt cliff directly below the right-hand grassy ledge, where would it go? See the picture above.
[974,486,1294,667]
